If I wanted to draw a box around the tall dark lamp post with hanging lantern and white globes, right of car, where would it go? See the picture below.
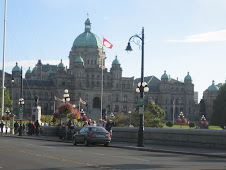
[126,28,149,147]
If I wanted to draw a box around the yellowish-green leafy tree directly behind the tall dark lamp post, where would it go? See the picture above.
[132,101,165,127]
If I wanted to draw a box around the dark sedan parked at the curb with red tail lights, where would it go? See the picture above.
[73,126,111,146]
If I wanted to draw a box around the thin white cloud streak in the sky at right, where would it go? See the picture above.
[167,30,226,42]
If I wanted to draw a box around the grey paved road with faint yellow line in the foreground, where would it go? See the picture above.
[0,136,226,170]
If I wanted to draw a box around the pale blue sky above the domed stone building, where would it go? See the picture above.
[0,0,226,101]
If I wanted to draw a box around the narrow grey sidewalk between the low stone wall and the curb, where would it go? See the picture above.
[1,134,226,158]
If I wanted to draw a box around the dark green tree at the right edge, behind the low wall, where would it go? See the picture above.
[211,84,226,128]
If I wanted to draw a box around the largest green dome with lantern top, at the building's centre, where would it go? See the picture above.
[73,18,103,48]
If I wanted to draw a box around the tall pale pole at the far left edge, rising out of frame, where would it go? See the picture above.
[1,0,7,120]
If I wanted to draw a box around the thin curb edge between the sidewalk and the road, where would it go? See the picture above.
[4,135,226,158]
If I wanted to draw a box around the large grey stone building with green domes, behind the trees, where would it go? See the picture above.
[1,18,194,120]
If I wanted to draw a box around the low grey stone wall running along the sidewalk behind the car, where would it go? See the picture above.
[44,126,226,149]
